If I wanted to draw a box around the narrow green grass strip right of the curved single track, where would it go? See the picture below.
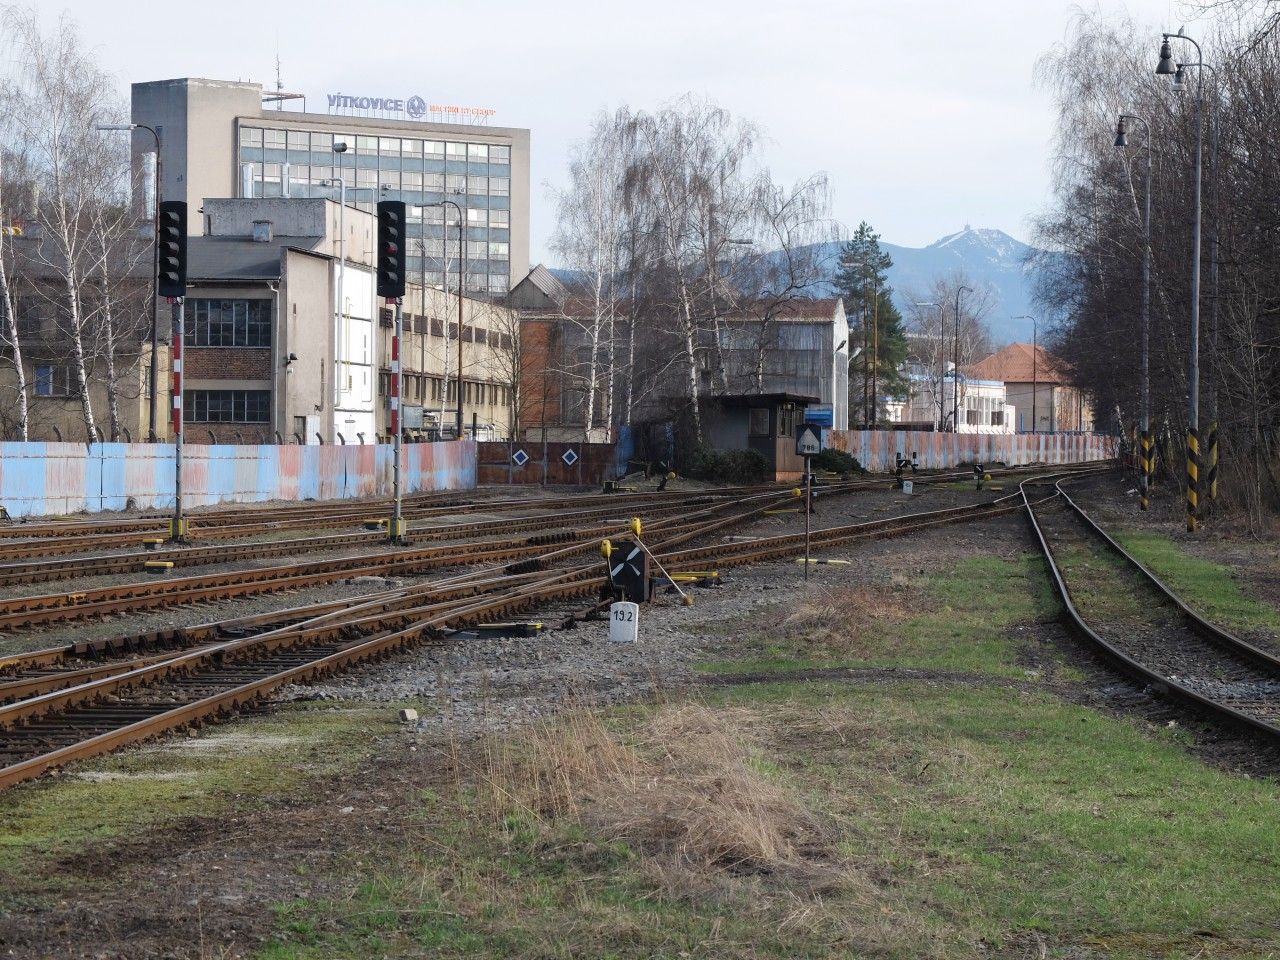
[1112,530,1280,634]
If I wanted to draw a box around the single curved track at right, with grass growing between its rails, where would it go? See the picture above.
[1020,481,1280,737]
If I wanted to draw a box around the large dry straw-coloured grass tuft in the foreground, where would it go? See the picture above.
[483,705,842,895]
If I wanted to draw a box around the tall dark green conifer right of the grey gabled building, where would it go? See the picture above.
[832,220,908,424]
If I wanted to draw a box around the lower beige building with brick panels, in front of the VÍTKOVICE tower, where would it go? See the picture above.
[179,198,513,444]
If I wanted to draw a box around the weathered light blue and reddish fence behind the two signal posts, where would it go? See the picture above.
[0,442,476,519]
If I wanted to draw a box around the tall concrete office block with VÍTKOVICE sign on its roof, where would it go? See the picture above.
[132,78,529,296]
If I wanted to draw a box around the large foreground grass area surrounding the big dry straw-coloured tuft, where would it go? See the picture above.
[260,684,1280,960]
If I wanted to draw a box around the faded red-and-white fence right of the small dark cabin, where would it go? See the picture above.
[823,430,1117,472]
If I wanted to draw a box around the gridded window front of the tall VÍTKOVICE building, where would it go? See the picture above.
[238,125,511,293]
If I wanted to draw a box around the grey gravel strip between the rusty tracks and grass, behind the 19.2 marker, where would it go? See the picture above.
[279,492,1028,735]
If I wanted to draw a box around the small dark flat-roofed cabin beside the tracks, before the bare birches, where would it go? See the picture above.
[703,393,819,483]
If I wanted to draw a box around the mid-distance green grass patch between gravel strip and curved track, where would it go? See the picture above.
[699,554,1061,678]
